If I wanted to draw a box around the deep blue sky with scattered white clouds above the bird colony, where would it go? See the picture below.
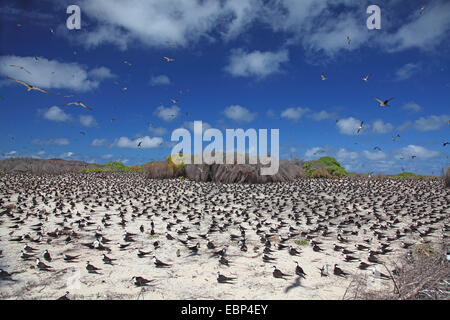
[0,0,450,175]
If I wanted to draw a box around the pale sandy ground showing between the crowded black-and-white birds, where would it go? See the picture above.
[0,174,449,300]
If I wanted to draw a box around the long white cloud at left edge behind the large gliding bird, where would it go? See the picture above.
[0,55,113,92]
